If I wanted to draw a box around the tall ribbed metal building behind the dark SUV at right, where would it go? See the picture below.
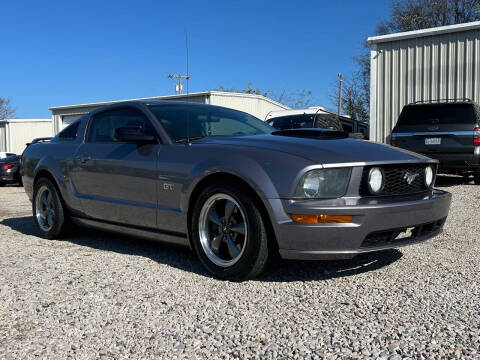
[368,21,480,142]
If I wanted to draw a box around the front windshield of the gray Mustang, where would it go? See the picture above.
[149,104,274,142]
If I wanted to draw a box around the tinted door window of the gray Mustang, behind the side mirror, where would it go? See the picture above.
[87,108,155,143]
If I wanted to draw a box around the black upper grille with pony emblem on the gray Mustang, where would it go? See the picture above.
[360,164,435,196]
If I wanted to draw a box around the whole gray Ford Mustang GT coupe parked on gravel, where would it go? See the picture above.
[22,101,451,280]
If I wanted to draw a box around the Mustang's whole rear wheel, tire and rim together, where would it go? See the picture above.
[32,178,68,239]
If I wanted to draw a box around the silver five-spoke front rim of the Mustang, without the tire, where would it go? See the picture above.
[198,193,248,267]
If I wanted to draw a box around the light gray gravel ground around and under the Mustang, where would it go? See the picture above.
[0,177,480,359]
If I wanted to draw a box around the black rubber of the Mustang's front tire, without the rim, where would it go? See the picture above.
[191,183,268,281]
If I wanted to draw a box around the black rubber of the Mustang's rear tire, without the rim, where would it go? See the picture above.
[32,178,65,239]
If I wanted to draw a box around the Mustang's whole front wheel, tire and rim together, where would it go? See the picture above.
[190,183,269,281]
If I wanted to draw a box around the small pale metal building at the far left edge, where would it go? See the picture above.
[0,119,53,154]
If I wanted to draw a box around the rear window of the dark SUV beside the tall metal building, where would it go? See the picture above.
[398,104,476,125]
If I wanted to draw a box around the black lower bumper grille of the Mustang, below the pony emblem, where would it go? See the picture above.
[361,218,446,248]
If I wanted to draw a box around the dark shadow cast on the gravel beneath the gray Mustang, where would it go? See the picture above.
[0,216,402,282]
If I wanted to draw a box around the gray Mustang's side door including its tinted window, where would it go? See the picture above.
[72,107,160,228]
